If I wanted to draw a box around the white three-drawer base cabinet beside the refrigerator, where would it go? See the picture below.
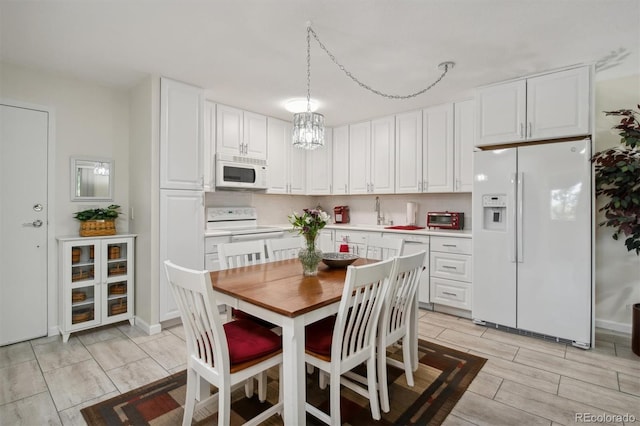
[429,237,472,310]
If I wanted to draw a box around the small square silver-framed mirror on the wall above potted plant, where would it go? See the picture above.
[71,157,114,201]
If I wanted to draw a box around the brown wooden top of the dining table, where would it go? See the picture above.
[211,258,377,317]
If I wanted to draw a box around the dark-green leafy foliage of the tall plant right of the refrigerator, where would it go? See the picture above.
[592,105,640,256]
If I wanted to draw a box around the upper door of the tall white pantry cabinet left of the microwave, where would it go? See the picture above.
[160,78,204,190]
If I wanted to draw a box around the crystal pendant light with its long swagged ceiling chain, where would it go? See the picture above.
[293,22,455,150]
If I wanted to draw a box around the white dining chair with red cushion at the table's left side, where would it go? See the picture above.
[164,260,283,426]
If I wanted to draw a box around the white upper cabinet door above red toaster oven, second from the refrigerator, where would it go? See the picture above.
[422,104,453,192]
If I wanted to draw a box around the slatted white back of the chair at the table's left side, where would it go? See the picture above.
[164,260,230,374]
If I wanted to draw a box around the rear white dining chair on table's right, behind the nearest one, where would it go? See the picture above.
[377,250,427,413]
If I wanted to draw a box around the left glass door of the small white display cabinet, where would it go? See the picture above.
[68,240,100,328]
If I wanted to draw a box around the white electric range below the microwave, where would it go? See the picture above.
[204,207,284,271]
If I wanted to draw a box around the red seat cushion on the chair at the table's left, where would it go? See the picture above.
[223,319,282,365]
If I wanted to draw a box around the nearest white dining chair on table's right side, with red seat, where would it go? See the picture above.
[305,259,394,425]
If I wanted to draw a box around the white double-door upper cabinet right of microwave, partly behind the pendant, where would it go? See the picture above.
[267,117,306,194]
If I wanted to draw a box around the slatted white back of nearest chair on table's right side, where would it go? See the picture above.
[331,259,393,363]
